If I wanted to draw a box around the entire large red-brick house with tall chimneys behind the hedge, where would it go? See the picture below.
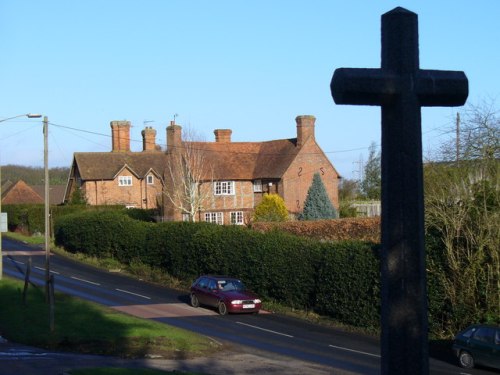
[65,116,340,224]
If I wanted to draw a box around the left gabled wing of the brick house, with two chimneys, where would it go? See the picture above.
[64,121,167,209]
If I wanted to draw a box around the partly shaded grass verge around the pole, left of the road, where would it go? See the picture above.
[0,277,222,359]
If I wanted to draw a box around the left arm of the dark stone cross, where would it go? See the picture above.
[330,68,400,105]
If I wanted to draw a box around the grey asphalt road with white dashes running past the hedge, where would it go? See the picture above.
[0,238,498,374]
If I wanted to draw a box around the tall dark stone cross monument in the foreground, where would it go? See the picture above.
[331,7,468,375]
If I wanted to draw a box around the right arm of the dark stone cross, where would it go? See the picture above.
[416,70,469,107]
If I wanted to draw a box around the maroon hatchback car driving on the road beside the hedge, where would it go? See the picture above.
[191,276,262,315]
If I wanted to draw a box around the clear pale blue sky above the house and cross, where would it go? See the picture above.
[0,0,500,178]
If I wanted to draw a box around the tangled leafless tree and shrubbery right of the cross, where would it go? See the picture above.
[424,100,500,333]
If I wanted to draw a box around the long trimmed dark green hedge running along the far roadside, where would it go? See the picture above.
[55,211,490,336]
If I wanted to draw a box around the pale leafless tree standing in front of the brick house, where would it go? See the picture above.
[165,128,213,221]
